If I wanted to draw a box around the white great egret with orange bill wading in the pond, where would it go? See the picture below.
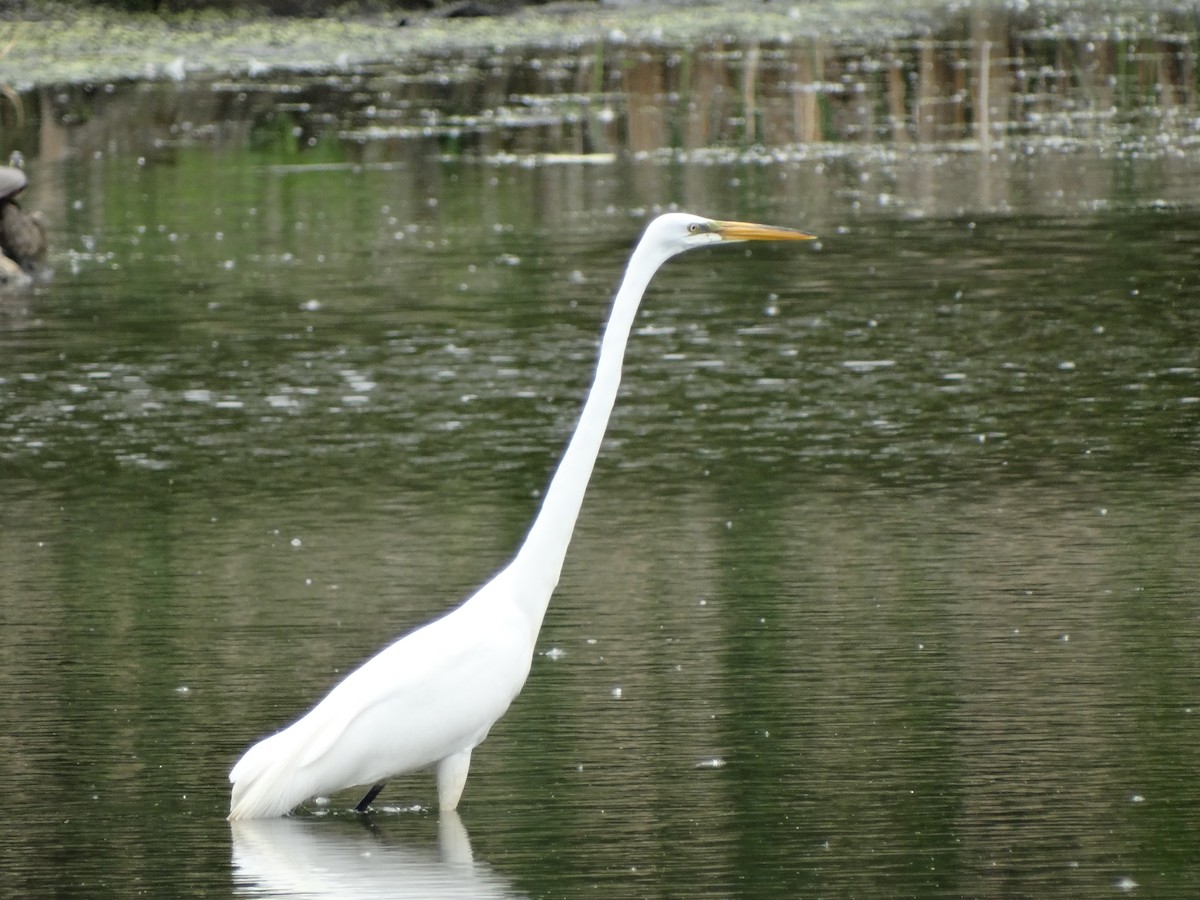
[229,212,814,820]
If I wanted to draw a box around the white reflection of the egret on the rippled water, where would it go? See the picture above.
[230,812,522,900]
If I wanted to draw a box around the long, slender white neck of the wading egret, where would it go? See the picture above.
[509,236,671,634]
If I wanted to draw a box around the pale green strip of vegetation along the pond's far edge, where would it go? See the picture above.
[7,0,1200,92]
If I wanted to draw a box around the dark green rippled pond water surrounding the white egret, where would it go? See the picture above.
[0,17,1200,898]
